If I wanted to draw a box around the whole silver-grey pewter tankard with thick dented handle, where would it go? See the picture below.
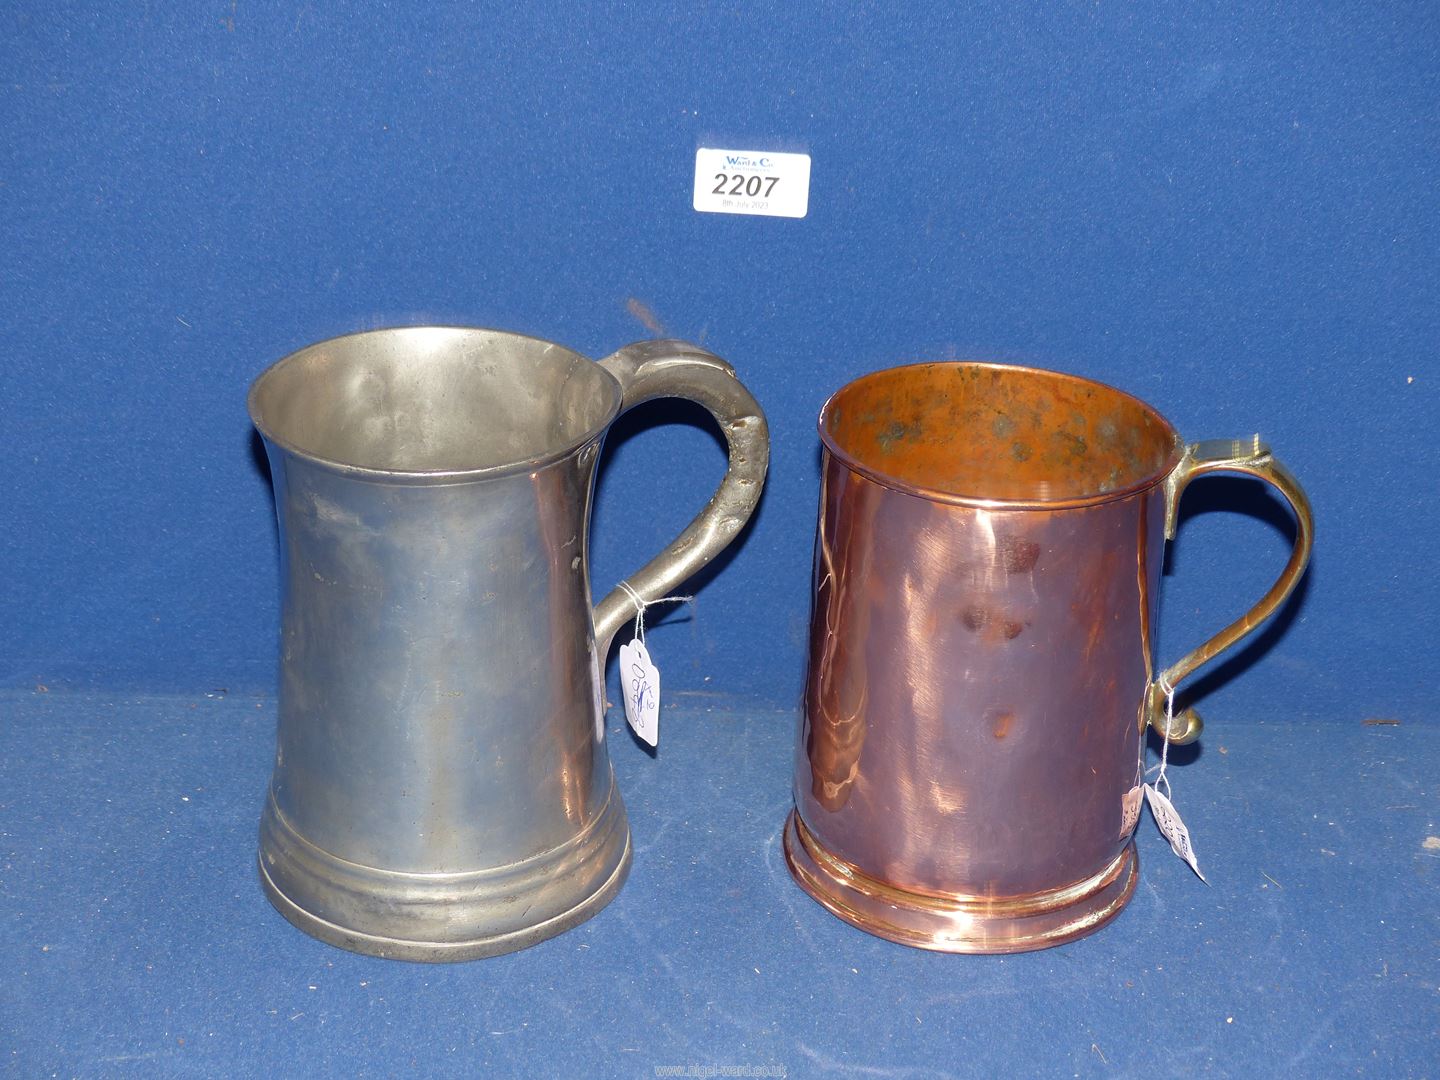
[249,327,769,960]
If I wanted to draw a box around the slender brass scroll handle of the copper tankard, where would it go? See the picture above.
[1146,435,1315,744]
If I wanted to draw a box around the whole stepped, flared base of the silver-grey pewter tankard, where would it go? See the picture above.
[258,789,631,963]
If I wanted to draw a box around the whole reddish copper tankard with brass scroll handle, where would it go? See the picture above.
[785,363,1313,953]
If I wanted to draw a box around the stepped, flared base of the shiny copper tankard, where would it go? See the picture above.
[785,811,1139,953]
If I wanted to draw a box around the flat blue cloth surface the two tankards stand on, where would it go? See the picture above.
[0,693,1440,1077]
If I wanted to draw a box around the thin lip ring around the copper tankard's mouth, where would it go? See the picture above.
[816,360,1185,510]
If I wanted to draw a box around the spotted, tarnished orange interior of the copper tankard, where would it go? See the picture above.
[819,361,1181,504]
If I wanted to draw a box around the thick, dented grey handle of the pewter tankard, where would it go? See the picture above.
[595,341,770,657]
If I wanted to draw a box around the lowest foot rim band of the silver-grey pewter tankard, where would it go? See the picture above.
[256,832,632,963]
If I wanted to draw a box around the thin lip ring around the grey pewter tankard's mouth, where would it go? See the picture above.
[245,323,624,482]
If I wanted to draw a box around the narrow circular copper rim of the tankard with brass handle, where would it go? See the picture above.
[818,360,1185,510]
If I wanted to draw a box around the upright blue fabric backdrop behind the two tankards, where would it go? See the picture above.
[0,1,1440,723]
